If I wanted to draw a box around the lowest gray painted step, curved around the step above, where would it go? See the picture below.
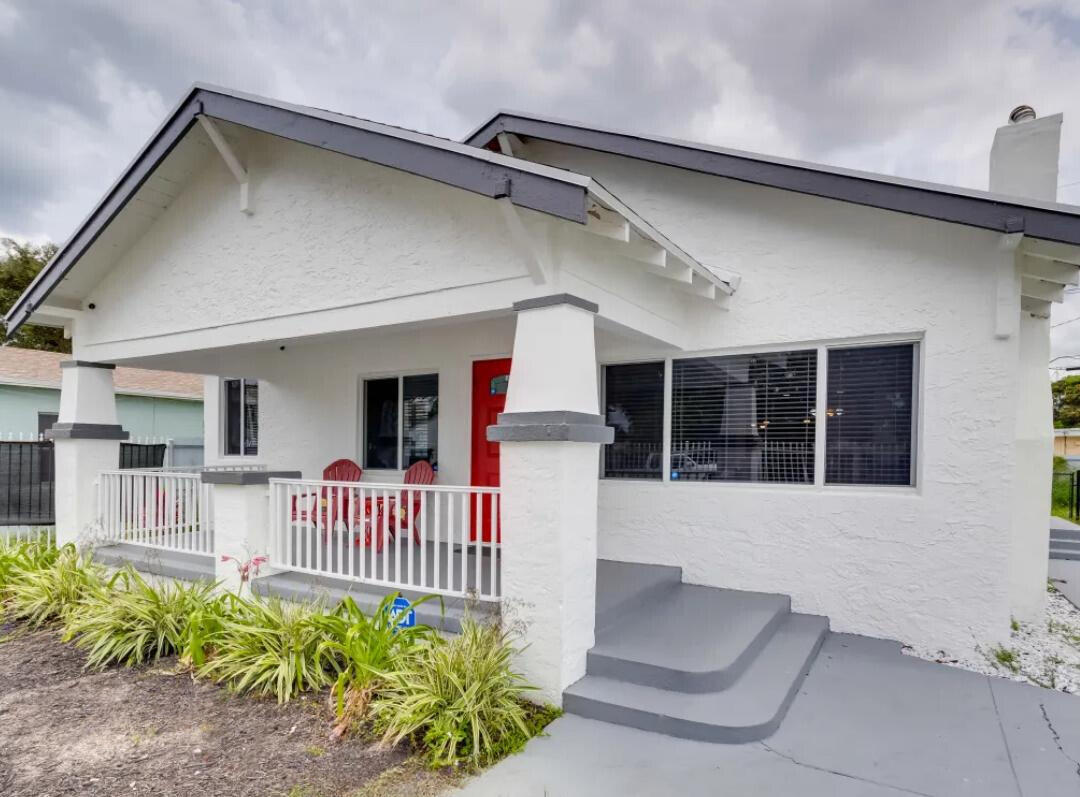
[563,614,828,744]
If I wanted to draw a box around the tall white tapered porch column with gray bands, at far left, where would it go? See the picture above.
[45,360,127,545]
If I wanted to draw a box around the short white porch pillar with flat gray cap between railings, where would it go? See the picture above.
[201,471,300,593]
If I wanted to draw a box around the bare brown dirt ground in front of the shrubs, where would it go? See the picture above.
[0,627,450,797]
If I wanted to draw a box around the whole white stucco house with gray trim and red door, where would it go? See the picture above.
[6,85,1080,739]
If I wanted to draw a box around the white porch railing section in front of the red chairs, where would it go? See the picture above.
[269,478,501,602]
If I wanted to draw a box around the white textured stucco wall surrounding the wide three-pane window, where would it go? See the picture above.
[518,145,1023,649]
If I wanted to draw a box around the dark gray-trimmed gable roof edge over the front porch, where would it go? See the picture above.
[3,83,737,338]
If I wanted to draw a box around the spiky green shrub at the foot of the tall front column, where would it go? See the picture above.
[372,619,532,767]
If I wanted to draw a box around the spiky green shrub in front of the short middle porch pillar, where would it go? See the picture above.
[198,597,334,703]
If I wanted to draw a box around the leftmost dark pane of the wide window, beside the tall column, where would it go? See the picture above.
[604,363,664,478]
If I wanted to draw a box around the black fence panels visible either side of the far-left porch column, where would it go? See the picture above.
[0,440,165,526]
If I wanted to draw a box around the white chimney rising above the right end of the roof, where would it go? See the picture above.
[990,105,1062,202]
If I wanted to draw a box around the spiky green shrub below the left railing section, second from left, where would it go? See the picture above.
[65,567,220,667]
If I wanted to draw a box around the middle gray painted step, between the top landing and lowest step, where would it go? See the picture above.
[586,584,791,693]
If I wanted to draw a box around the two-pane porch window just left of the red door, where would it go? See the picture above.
[363,374,438,470]
